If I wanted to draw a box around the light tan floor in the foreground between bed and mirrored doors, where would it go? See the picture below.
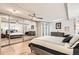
[1,41,35,55]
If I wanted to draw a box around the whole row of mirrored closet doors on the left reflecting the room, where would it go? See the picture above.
[0,14,37,46]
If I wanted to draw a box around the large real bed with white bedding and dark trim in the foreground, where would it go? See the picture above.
[29,35,79,55]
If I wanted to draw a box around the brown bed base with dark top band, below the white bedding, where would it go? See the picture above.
[29,43,67,55]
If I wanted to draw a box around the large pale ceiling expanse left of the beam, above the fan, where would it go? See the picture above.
[0,3,66,21]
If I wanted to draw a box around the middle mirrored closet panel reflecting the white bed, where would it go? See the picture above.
[7,17,23,43]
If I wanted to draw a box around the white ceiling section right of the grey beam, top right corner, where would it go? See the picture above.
[68,3,79,19]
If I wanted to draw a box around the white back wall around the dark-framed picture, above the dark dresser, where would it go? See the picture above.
[51,19,74,35]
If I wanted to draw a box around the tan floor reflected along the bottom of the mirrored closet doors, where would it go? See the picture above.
[1,36,34,46]
